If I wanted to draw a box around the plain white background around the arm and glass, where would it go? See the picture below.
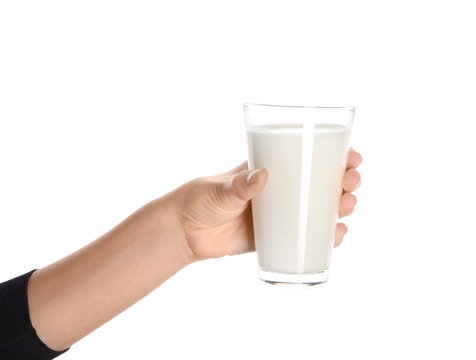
[0,0,476,359]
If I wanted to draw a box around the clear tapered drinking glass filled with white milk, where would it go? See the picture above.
[244,103,355,285]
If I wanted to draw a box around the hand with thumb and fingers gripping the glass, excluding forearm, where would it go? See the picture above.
[172,149,362,260]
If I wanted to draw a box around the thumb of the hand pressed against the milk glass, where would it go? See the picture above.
[222,169,269,207]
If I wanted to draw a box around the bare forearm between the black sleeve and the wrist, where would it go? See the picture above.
[28,196,192,350]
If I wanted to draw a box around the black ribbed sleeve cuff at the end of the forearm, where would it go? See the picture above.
[0,270,67,360]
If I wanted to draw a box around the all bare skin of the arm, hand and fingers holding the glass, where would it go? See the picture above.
[28,149,362,350]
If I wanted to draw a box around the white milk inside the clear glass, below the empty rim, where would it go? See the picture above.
[248,124,350,274]
